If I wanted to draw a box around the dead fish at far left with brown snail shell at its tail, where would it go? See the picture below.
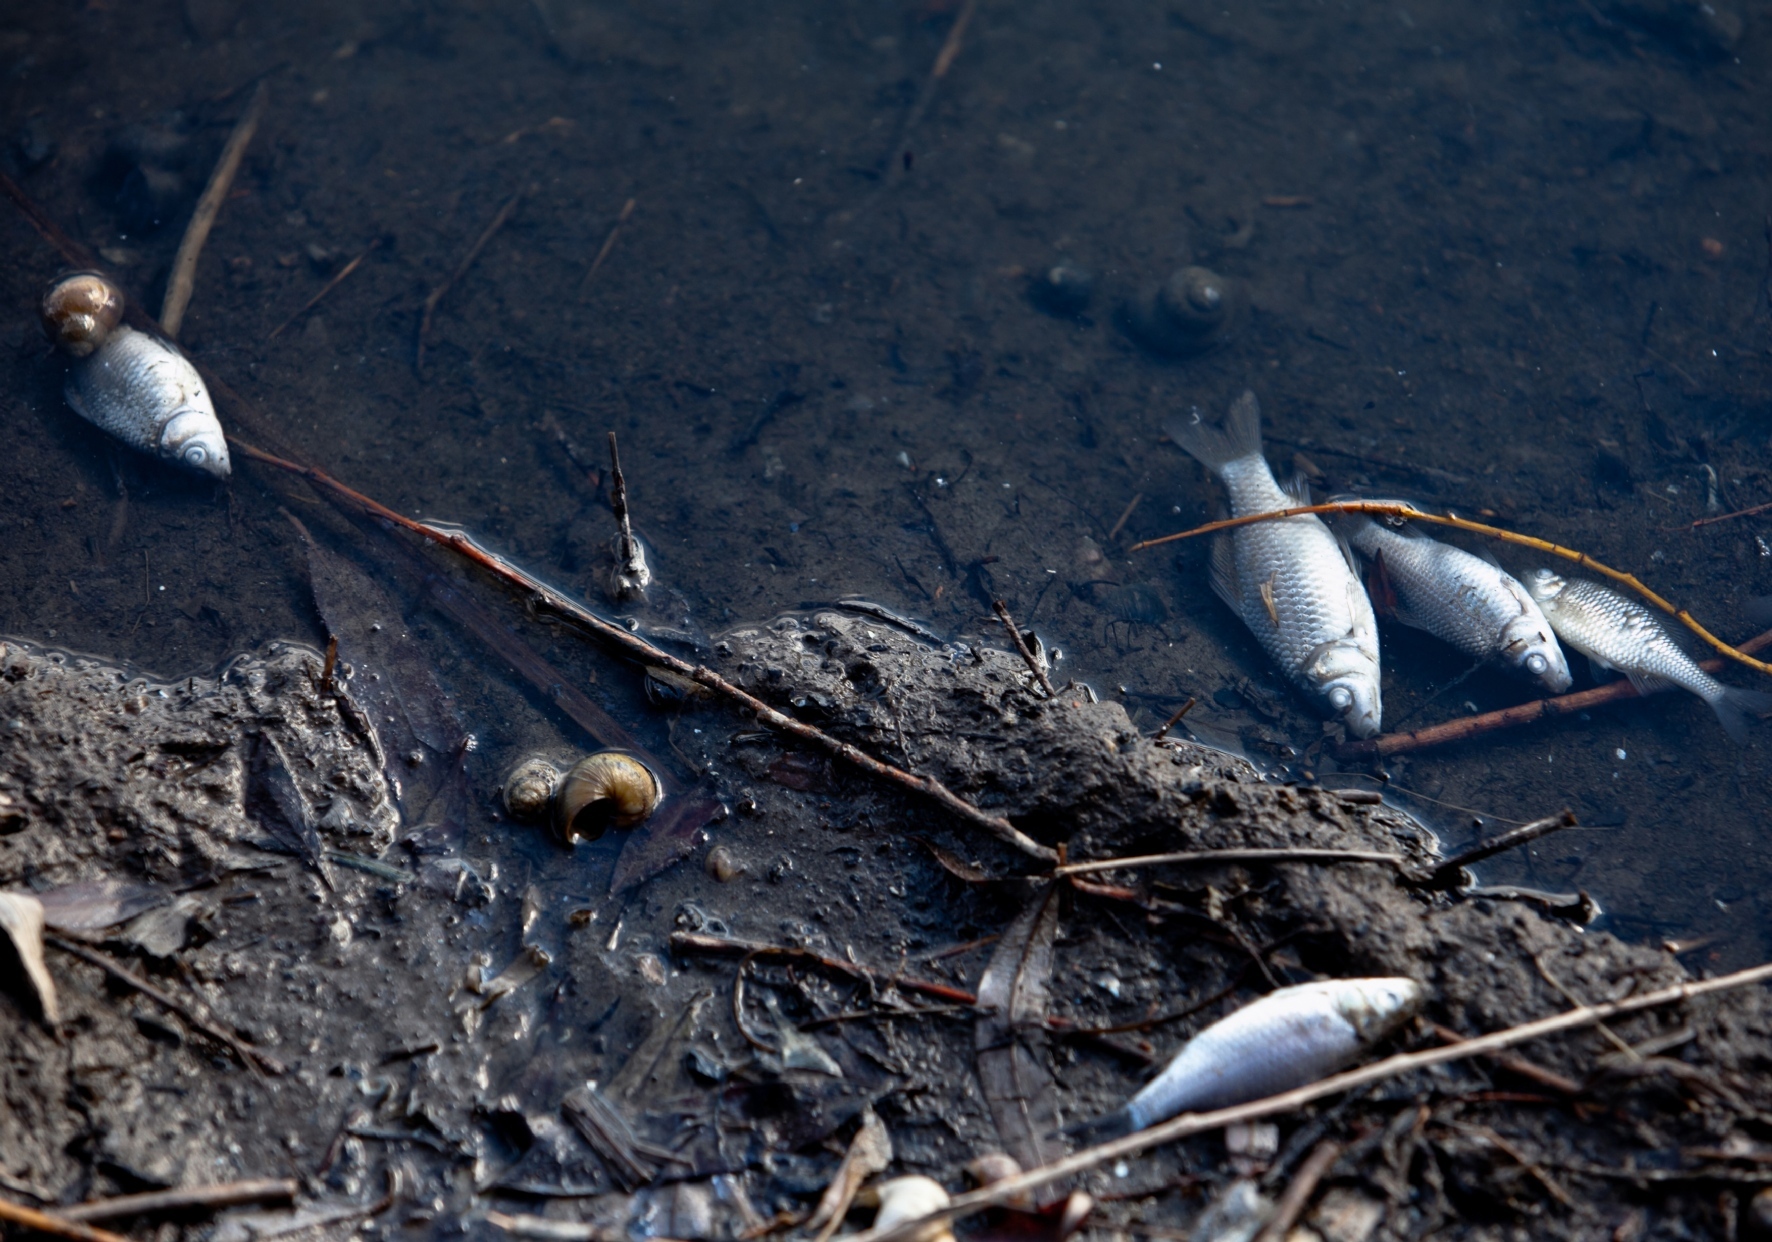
[43,271,229,478]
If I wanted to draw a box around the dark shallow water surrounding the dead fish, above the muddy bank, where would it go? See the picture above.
[0,0,1772,964]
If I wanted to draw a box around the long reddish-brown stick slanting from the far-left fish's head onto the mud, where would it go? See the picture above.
[229,438,1058,863]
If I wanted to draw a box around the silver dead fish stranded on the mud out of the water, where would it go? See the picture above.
[1077,978,1426,1139]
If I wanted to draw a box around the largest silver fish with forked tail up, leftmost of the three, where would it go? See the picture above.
[1166,392,1384,737]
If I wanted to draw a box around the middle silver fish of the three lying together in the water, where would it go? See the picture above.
[1336,514,1570,695]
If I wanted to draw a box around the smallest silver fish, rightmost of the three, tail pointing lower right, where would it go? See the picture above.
[1526,569,1772,744]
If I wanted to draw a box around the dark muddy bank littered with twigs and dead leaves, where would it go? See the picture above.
[10,609,1772,1238]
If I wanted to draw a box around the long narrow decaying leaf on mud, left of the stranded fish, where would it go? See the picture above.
[973,886,1058,1194]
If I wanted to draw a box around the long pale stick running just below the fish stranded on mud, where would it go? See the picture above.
[852,964,1772,1242]
